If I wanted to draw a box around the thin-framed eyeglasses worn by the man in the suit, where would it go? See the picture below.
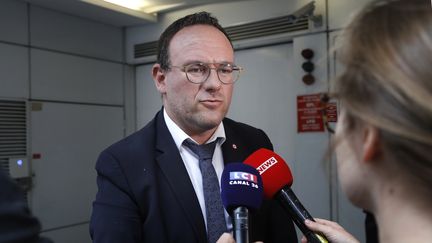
[171,62,243,84]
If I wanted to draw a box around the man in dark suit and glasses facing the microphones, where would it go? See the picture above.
[90,12,297,243]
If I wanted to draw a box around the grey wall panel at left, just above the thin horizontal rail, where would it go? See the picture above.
[31,49,123,105]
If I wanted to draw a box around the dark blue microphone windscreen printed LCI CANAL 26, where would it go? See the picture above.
[221,163,263,213]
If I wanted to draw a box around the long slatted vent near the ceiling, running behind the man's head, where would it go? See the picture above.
[134,16,309,58]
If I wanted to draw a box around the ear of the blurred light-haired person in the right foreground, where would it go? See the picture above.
[363,125,381,162]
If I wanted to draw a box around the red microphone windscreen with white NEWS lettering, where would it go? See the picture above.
[244,148,293,198]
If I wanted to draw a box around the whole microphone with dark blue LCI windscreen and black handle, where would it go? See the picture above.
[221,163,263,243]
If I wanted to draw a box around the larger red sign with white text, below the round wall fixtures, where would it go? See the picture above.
[297,94,324,132]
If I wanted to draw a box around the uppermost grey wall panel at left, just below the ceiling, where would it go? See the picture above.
[30,6,123,61]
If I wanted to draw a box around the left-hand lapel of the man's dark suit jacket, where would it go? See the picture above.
[156,112,207,242]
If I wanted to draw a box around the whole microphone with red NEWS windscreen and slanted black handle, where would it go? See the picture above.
[244,148,328,243]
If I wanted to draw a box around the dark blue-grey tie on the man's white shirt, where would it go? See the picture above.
[184,139,227,243]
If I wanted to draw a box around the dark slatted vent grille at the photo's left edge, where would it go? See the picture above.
[0,100,27,160]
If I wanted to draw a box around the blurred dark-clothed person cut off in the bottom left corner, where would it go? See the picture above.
[0,171,51,243]
